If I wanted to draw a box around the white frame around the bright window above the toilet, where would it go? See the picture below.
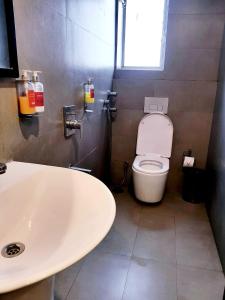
[116,0,169,71]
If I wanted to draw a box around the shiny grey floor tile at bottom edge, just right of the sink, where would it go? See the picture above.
[67,253,129,300]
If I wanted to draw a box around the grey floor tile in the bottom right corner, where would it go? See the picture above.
[177,267,225,300]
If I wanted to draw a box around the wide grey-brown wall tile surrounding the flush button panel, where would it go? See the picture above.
[113,79,217,114]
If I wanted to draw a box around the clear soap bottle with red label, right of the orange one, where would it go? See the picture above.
[32,71,45,113]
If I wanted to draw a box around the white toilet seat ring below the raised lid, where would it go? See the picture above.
[133,154,169,175]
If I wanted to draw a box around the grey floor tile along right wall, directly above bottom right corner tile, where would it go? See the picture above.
[176,233,222,271]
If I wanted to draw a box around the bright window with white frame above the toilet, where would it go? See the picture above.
[117,0,169,70]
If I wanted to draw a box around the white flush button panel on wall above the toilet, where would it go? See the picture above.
[144,97,169,114]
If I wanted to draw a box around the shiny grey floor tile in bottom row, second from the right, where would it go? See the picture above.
[123,258,177,300]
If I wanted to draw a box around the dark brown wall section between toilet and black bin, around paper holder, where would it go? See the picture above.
[168,112,212,191]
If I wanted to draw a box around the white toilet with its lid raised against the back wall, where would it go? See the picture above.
[132,112,173,203]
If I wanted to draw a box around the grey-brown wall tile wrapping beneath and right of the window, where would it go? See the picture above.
[114,49,220,81]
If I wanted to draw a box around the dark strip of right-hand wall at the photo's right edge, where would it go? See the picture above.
[207,31,225,270]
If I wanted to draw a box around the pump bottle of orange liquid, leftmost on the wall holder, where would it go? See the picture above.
[17,70,35,117]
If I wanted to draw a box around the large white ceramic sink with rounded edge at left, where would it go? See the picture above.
[0,162,116,293]
